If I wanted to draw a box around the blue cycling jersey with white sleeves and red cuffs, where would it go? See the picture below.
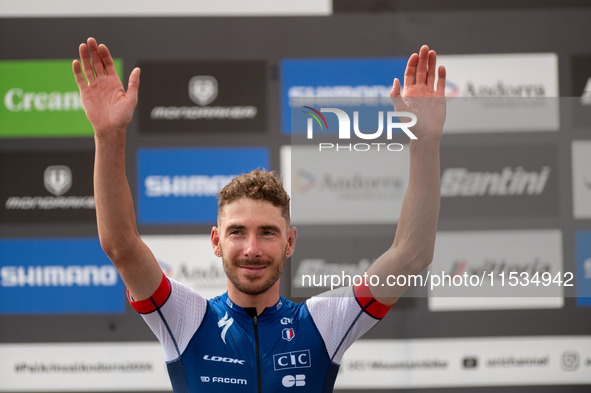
[131,277,390,393]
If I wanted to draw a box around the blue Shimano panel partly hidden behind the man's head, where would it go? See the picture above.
[137,148,269,224]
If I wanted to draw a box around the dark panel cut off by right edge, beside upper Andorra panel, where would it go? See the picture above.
[571,55,591,126]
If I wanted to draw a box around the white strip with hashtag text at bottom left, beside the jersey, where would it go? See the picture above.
[0,342,172,392]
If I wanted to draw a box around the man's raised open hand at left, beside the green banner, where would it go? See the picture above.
[72,37,140,137]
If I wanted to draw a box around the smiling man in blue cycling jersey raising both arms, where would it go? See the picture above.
[73,38,445,393]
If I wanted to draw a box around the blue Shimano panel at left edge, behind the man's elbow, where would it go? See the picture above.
[0,238,125,314]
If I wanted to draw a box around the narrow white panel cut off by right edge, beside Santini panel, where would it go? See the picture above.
[571,141,591,219]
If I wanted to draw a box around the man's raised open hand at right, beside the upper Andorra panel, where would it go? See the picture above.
[390,45,446,140]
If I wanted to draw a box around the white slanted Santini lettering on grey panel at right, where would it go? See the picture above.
[441,166,551,197]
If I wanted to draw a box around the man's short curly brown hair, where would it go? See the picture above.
[218,168,290,225]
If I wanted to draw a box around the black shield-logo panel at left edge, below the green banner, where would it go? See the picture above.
[0,150,96,223]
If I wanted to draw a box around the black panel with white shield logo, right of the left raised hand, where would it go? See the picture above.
[139,62,267,134]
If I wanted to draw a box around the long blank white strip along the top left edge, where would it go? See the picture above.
[0,0,332,18]
